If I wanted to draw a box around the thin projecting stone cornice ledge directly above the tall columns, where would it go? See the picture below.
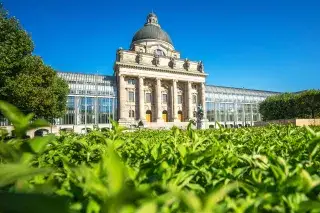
[115,61,208,77]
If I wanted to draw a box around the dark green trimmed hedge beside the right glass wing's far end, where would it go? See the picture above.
[259,90,320,121]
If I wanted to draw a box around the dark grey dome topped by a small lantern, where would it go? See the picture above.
[132,13,172,45]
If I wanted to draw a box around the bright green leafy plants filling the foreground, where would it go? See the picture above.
[0,100,320,213]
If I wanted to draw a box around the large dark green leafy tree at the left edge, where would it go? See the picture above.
[0,4,68,119]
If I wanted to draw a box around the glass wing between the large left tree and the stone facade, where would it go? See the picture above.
[56,72,117,125]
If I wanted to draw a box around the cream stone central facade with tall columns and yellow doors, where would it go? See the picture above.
[114,13,207,124]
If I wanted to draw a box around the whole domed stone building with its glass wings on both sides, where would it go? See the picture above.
[0,13,276,132]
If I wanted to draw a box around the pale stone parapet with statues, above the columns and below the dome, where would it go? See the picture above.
[117,49,204,73]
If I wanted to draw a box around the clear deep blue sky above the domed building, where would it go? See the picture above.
[0,0,320,92]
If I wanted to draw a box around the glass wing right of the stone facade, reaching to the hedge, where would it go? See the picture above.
[206,85,278,127]
